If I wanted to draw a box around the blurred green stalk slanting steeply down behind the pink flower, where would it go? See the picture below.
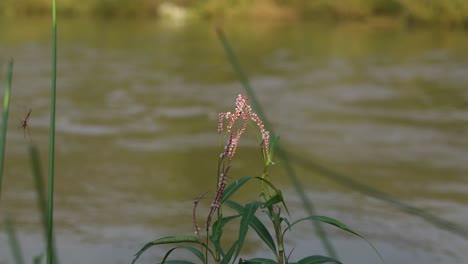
[216,28,338,259]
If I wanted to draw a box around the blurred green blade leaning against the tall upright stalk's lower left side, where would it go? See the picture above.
[29,144,58,263]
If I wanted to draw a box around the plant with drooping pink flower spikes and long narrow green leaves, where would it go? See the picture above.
[132,95,383,264]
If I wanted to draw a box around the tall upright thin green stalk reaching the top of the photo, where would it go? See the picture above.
[47,0,57,264]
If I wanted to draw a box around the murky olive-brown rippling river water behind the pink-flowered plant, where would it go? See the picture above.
[0,19,468,264]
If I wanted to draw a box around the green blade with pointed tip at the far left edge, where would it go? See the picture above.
[0,59,13,197]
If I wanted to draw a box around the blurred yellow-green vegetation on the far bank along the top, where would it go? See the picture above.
[0,0,468,26]
